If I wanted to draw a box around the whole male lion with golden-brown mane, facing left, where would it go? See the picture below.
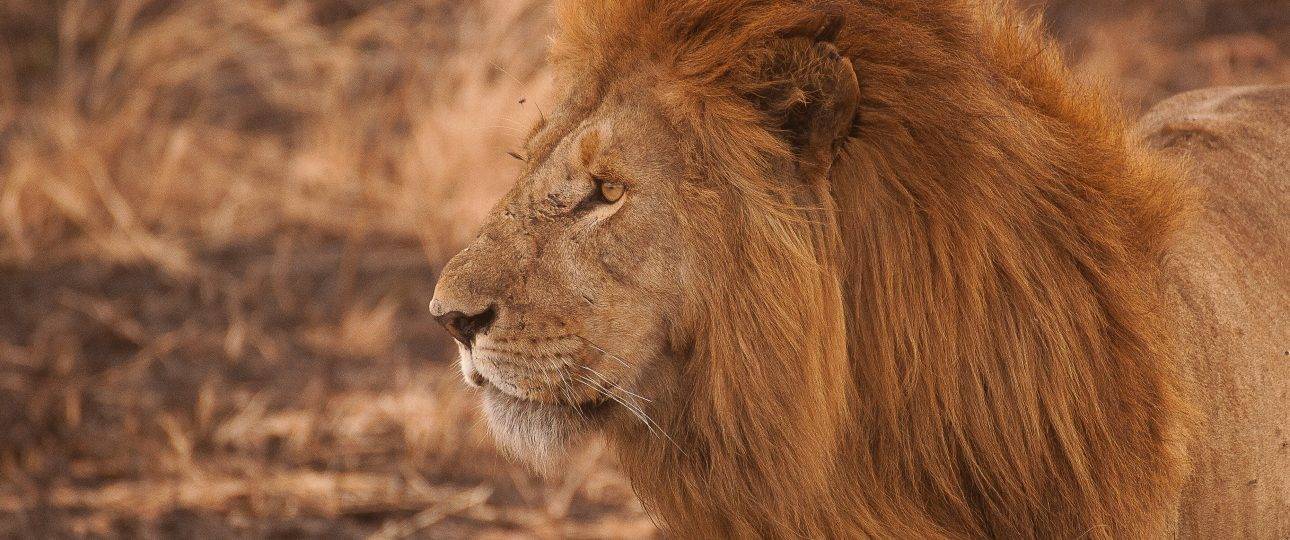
[431,0,1290,537]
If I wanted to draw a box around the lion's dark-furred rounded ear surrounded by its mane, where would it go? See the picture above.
[748,14,860,169]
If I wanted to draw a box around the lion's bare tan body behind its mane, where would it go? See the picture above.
[1140,86,1290,539]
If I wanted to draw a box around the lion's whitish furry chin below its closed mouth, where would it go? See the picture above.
[484,385,613,474]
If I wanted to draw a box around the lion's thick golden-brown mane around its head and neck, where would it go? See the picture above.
[552,0,1191,537]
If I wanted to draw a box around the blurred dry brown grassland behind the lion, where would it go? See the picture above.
[0,0,1290,537]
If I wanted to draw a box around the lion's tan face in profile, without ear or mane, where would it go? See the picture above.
[431,90,693,465]
